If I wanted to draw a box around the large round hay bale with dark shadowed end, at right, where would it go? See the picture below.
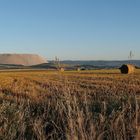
[120,64,135,74]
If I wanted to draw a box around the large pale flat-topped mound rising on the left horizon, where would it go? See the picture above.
[0,54,47,66]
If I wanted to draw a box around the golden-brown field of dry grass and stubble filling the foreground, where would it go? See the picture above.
[0,70,140,140]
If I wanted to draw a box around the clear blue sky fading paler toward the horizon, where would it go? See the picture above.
[0,0,140,60]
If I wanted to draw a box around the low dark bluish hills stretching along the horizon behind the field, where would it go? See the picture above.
[0,60,140,70]
